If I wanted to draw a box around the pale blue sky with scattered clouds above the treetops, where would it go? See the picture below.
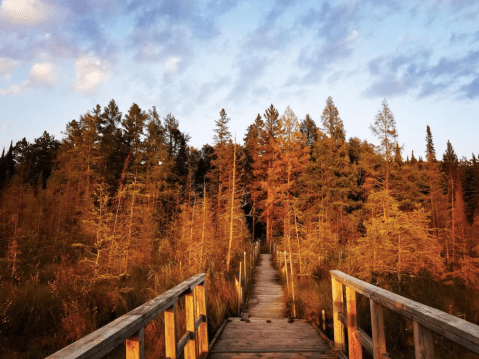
[0,0,479,158]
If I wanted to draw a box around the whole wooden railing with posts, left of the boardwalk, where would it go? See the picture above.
[48,273,208,359]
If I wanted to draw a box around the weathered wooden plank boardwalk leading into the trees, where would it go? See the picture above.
[208,254,337,359]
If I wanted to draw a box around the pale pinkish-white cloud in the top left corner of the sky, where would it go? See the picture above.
[0,0,56,25]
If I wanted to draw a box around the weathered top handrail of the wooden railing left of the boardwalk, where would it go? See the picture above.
[47,273,208,359]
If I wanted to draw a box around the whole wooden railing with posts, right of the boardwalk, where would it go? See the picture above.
[331,270,479,359]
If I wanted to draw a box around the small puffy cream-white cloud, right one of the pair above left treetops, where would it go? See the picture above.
[75,56,110,92]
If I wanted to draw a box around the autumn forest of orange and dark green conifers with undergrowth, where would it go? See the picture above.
[0,97,479,358]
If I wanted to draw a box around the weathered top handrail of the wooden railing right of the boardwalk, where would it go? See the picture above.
[330,270,479,358]
